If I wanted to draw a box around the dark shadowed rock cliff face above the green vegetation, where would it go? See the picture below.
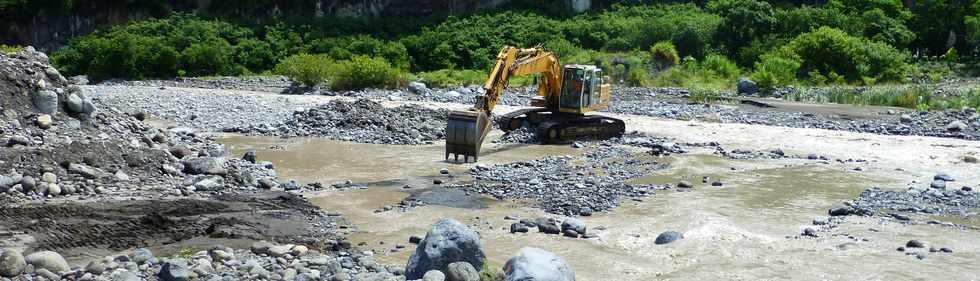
[0,0,588,51]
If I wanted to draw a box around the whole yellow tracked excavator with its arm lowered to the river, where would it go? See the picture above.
[446,46,626,162]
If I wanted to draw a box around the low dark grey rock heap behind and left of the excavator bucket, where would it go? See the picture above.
[228,99,448,145]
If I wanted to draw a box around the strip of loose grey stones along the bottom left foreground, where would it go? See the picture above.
[0,238,404,281]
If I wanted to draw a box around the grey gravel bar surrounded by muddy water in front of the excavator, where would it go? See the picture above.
[454,146,666,216]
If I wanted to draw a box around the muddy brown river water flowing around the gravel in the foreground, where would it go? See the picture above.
[221,136,980,280]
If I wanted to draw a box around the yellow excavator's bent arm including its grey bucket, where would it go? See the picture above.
[446,46,562,161]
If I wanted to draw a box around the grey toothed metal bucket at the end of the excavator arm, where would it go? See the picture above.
[446,110,490,162]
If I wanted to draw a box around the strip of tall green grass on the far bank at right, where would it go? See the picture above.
[783,85,980,110]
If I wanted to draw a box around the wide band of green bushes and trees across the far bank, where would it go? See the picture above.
[34,0,980,90]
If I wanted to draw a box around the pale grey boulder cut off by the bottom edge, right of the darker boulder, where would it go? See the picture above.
[504,247,575,281]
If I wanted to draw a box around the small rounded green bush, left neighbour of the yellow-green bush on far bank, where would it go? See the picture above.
[274,54,337,87]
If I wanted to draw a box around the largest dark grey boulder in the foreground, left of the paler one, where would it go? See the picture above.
[405,218,486,280]
